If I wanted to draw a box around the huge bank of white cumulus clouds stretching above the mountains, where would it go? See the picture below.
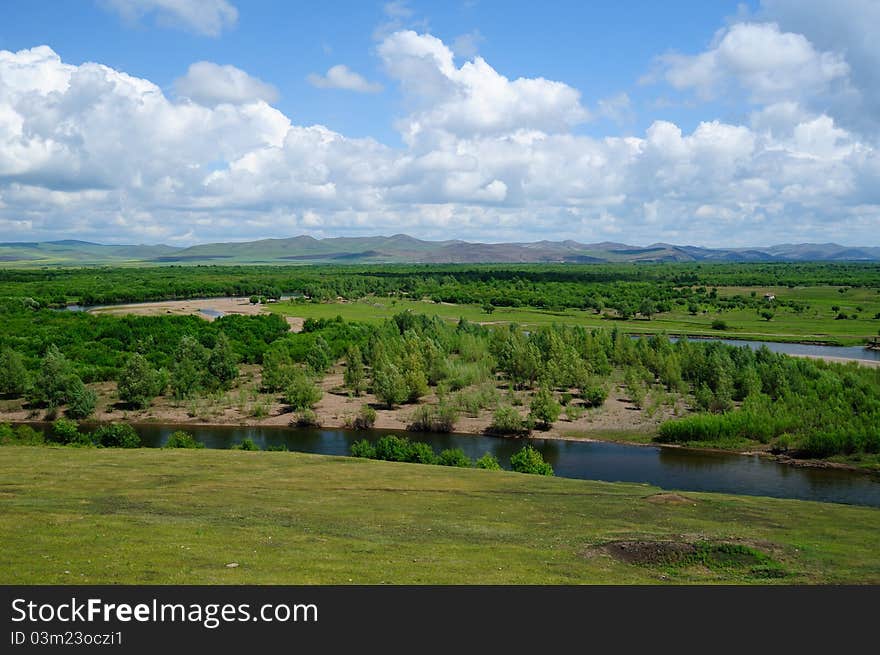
[0,32,880,245]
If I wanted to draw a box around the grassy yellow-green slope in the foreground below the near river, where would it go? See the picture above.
[0,447,880,584]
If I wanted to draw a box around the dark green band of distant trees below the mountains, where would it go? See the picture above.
[0,263,880,312]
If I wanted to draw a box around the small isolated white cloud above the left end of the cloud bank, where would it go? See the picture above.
[174,61,278,107]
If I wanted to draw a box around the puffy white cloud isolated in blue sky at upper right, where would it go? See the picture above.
[660,23,849,102]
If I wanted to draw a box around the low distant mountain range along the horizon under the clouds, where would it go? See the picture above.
[0,234,880,267]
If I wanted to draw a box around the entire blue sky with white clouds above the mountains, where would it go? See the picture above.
[0,0,880,247]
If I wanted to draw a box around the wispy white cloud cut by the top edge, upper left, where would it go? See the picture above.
[100,0,238,36]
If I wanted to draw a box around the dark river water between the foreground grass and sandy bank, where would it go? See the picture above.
[120,425,880,507]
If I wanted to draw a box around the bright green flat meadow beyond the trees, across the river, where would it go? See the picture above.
[267,286,880,345]
